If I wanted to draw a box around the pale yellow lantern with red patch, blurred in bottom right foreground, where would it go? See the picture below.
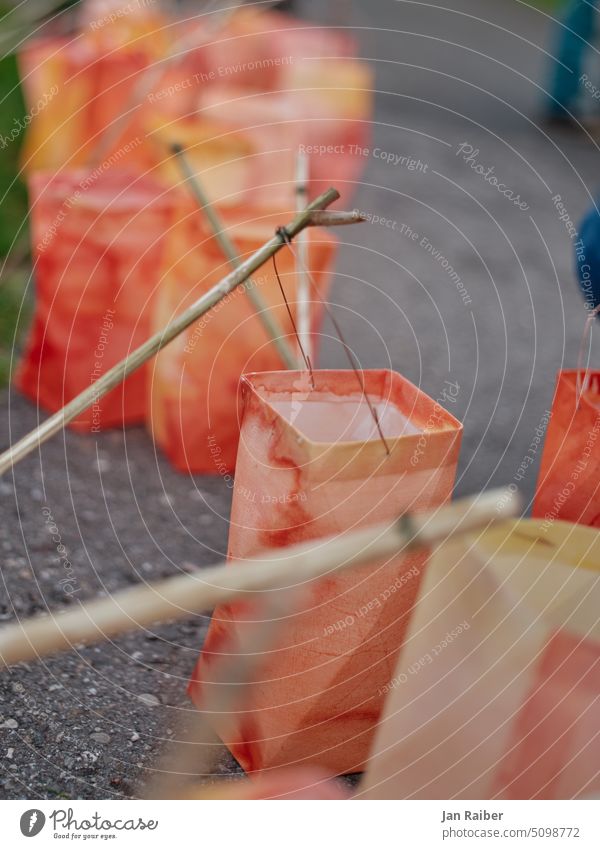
[359,520,600,799]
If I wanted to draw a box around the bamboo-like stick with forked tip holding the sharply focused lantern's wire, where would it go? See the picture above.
[0,189,339,475]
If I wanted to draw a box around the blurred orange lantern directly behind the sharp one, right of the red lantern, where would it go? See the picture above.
[148,201,335,475]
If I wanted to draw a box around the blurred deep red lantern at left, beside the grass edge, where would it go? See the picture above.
[15,169,172,430]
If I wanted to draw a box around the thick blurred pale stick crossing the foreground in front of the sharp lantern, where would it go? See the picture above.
[0,490,520,667]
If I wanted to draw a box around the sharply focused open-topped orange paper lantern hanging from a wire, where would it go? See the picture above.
[190,370,462,774]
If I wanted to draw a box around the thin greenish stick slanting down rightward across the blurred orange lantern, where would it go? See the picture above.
[171,143,298,369]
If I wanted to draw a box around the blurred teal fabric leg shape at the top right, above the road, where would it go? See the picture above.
[548,0,599,116]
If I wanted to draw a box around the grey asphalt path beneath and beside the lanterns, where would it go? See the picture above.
[0,0,598,798]
